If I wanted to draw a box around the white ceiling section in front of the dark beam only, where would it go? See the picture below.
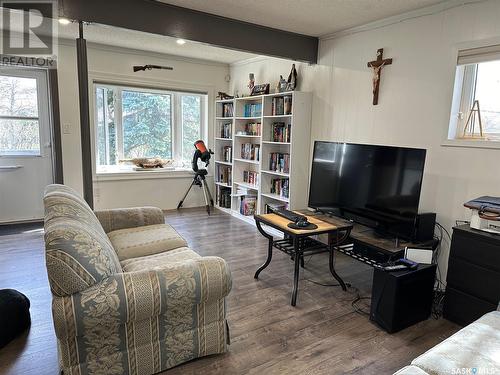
[158,0,443,37]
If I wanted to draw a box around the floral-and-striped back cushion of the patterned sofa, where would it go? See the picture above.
[44,185,121,296]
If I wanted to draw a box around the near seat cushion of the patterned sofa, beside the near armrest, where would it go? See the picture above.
[121,247,201,272]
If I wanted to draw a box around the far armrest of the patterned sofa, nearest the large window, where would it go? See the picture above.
[95,207,165,233]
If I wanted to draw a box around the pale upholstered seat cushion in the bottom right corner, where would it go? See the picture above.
[412,311,500,374]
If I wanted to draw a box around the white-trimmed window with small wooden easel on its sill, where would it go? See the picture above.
[448,45,500,141]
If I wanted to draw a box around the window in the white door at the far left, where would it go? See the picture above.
[0,75,40,156]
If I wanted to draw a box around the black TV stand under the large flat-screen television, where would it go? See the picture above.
[298,210,439,268]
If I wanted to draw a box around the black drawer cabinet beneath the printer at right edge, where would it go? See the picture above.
[443,225,500,325]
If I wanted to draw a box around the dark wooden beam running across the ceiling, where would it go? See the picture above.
[59,0,318,63]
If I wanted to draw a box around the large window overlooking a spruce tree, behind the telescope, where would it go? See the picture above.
[94,84,207,172]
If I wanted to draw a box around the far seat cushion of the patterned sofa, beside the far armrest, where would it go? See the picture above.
[108,224,187,260]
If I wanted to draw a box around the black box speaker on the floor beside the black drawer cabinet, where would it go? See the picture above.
[370,264,436,333]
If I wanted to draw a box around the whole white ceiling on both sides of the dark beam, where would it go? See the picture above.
[0,0,450,64]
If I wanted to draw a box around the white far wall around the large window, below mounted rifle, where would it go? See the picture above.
[58,42,229,209]
